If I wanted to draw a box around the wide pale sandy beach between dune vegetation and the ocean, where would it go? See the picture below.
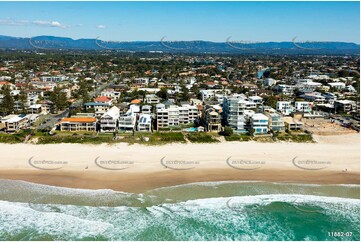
[0,134,360,192]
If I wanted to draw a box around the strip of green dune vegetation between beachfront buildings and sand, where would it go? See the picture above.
[0,129,313,145]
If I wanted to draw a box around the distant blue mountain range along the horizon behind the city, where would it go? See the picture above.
[0,35,360,55]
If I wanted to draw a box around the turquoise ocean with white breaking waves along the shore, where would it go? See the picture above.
[0,180,360,241]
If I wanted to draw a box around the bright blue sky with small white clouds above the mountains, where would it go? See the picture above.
[0,2,360,43]
